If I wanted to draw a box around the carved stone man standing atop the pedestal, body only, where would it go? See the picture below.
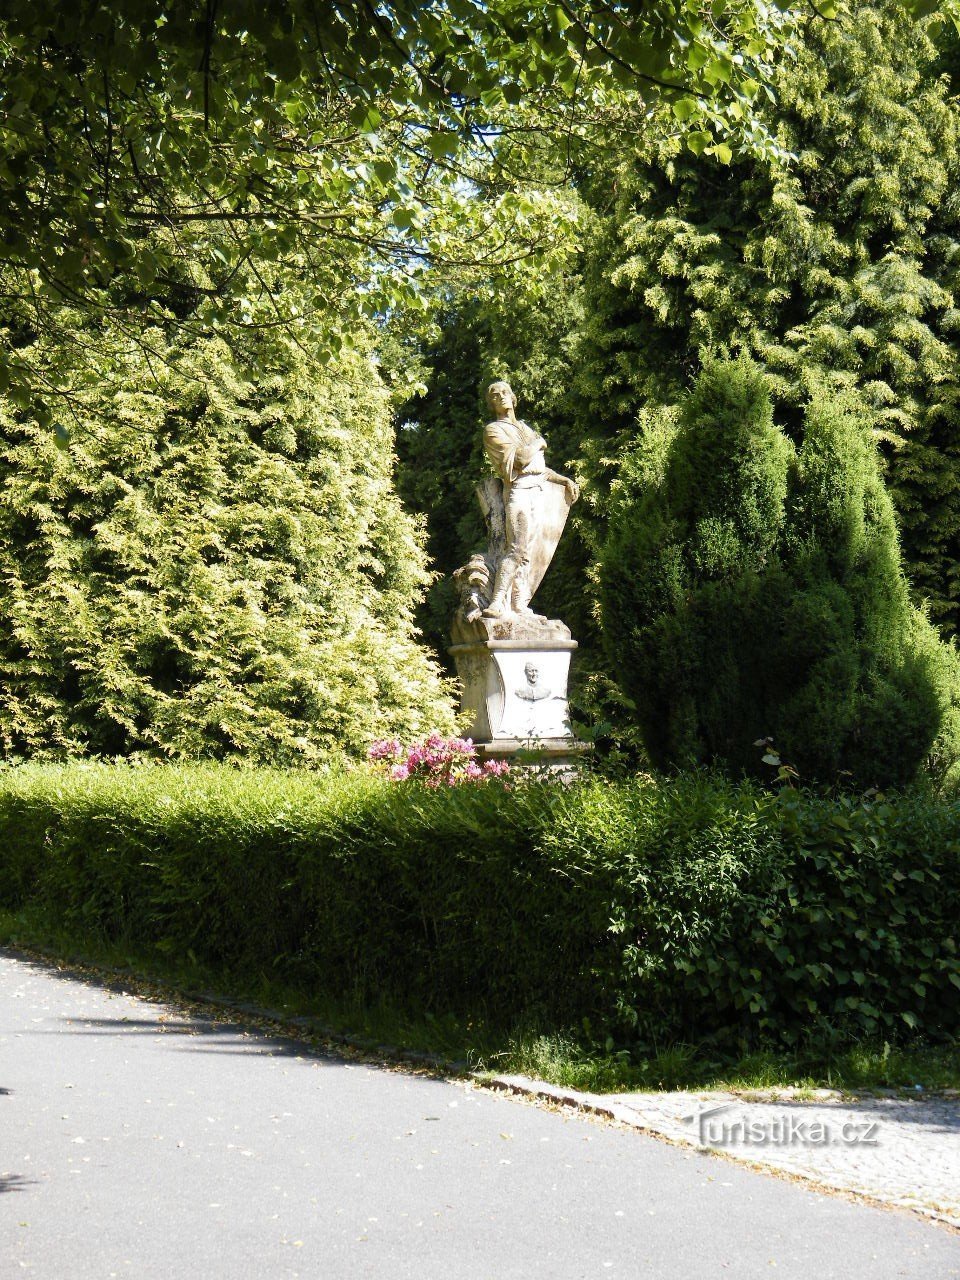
[484,383,580,618]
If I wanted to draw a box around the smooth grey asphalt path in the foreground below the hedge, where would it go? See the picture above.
[0,955,960,1280]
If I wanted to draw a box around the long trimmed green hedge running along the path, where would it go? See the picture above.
[0,764,960,1044]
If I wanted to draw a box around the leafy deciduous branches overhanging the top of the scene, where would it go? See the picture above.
[0,0,931,350]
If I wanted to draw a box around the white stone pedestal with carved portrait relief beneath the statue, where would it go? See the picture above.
[451,623,589,776]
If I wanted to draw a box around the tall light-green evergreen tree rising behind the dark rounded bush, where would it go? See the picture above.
[580,0,960,631]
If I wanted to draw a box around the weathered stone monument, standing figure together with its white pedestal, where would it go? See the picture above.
[451,373,586,762]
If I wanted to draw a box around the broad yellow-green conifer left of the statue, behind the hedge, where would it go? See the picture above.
[0,328,451,762]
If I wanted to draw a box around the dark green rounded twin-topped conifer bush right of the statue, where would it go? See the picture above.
[600,360,960,787]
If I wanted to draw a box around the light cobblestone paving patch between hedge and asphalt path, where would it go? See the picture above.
[484,1075,960,1228]
